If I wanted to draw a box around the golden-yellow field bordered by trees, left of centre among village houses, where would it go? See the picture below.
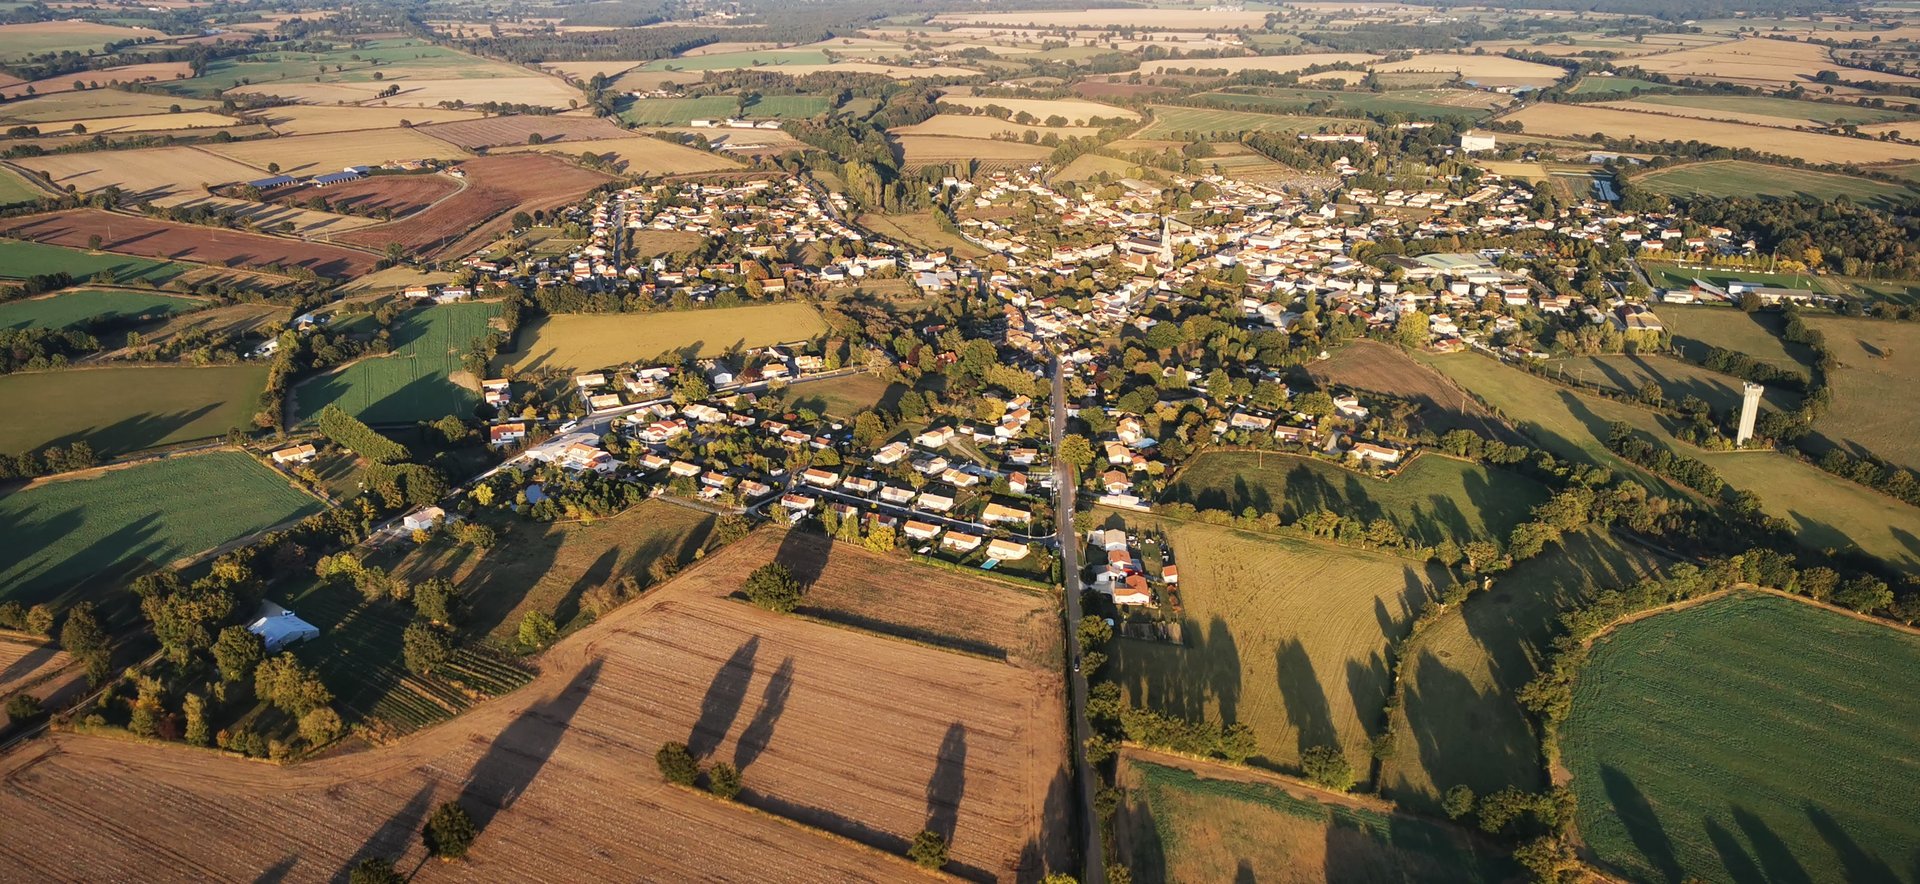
[503,302,826,371]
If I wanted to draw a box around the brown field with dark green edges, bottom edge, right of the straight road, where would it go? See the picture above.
[1116,749,1517,884]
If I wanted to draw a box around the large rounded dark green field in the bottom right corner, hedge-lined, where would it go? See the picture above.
[1561,594,1920,882]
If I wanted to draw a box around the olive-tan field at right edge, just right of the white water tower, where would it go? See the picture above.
[1807,317,1920,469]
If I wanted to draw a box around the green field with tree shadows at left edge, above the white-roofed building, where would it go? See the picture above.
[0,452,321,605]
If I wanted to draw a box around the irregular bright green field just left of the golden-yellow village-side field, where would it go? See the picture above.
[294,304,499,423]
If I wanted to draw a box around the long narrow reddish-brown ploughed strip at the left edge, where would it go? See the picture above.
[0,209,376,277]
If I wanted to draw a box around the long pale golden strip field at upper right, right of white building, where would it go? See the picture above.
[1505,104,1920,163]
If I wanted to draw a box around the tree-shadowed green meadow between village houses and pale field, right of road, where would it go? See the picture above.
[1164,452,1548,546]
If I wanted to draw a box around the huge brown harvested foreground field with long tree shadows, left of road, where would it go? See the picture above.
[0,526,1066,882]
